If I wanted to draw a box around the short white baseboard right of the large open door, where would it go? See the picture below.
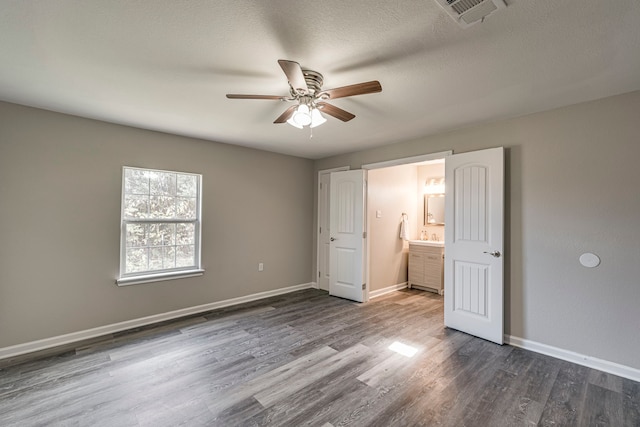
[504,335,640,381]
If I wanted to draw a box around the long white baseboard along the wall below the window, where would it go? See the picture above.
[0,283,313,360]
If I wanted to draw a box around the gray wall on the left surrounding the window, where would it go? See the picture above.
[0,103,314,347]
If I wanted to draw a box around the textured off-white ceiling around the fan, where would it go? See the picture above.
[0,0,640,158]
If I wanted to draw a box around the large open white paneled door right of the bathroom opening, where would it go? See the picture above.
[444,147,504,344]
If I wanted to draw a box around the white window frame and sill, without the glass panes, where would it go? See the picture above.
[116,166,204,286]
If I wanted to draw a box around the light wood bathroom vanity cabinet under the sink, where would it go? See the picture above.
[409,241,444,295]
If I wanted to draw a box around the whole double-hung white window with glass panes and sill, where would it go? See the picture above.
[117,167,203,285]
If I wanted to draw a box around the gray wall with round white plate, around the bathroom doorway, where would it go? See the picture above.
[314,92,640,369]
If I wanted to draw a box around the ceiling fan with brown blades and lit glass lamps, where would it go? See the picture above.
[227,59,382,129]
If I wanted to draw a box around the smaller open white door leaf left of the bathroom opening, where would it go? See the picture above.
[329,170,366,302]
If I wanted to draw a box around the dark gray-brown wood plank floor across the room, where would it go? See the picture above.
[0,289,640,427]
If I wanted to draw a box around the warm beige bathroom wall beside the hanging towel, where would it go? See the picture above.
[367,165,422,292]
